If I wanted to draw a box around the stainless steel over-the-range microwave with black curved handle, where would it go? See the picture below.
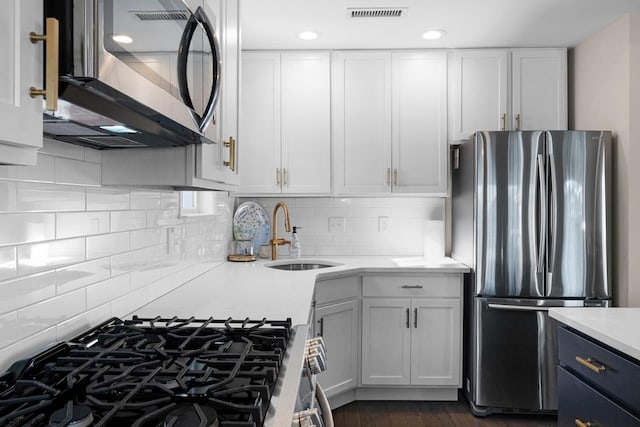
[44,0,221,149]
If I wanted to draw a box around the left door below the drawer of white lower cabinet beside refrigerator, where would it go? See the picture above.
[362,299,411,385]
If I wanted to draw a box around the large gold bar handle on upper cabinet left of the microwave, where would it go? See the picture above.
[29,18,60,110]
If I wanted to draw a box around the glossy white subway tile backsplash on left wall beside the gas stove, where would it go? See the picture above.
[0,140,233,372]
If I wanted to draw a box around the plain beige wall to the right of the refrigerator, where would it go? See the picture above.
[569,14,640,306]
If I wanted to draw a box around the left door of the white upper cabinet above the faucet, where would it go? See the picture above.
[238,52,282,193]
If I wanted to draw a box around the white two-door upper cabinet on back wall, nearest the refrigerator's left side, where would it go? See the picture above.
[333,51,447,194]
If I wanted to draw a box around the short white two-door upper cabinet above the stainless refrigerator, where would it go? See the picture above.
[451,49,568,140]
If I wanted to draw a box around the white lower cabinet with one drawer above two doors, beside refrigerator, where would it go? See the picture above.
[362,275,462,387]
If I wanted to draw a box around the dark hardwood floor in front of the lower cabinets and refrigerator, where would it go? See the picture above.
[333,399,557,427]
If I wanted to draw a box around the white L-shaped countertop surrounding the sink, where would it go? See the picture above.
[131,256,469,325]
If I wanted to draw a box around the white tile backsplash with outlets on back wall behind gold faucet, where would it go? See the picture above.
[239,197,444,256]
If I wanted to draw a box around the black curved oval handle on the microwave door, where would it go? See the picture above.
[178,6,221,133]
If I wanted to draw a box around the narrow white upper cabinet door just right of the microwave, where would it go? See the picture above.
[196,0,240,185]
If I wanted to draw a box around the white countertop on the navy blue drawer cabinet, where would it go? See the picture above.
[549,307,640,360]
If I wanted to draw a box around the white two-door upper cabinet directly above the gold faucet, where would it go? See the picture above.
[239,52,331,194]
